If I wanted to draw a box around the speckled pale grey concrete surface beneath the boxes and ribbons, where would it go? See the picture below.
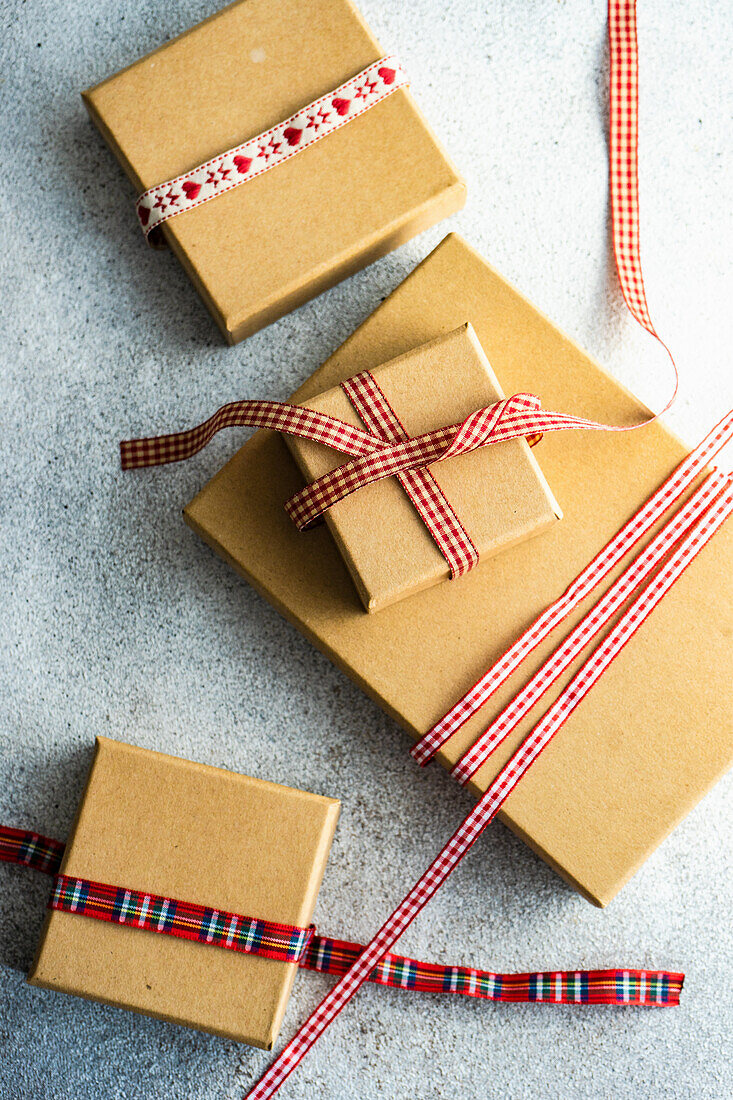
[0,0,733,1100]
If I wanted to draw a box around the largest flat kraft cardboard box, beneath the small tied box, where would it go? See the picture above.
[185,235,733,905]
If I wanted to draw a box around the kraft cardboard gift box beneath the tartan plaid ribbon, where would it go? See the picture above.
[29,737,339,1049]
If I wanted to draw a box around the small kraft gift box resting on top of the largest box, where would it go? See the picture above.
[283,323,561,612]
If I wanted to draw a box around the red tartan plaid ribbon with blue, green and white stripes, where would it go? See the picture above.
[0,825,683,1007]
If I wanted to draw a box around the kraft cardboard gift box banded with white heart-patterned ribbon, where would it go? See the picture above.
[84,0,466,343]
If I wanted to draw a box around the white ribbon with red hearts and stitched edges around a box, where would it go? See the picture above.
[135,57,409,244]
